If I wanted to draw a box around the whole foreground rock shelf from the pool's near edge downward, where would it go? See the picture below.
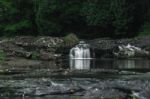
[0,69,150,99]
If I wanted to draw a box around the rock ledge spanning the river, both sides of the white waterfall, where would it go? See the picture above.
[0,36,150,60]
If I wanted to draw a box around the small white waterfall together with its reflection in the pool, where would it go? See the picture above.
[69,41,94,69]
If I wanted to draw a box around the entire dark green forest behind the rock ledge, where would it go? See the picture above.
[0,0,150,38]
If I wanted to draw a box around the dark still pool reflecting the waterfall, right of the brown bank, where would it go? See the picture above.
[70,59,150,69]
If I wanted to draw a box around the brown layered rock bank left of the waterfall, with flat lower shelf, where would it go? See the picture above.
[0,36,69,70]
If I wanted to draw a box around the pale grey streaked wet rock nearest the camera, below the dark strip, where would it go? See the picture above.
[0,78,150,99]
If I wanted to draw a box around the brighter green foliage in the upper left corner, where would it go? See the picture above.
[0,0,35,36]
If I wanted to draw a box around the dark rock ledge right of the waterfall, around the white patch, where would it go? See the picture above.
[89,36,150,58]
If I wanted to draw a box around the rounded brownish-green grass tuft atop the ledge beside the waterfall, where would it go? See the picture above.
[63,33,79,46]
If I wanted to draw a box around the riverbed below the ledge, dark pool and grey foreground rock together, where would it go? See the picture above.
[0,59,150,99]
